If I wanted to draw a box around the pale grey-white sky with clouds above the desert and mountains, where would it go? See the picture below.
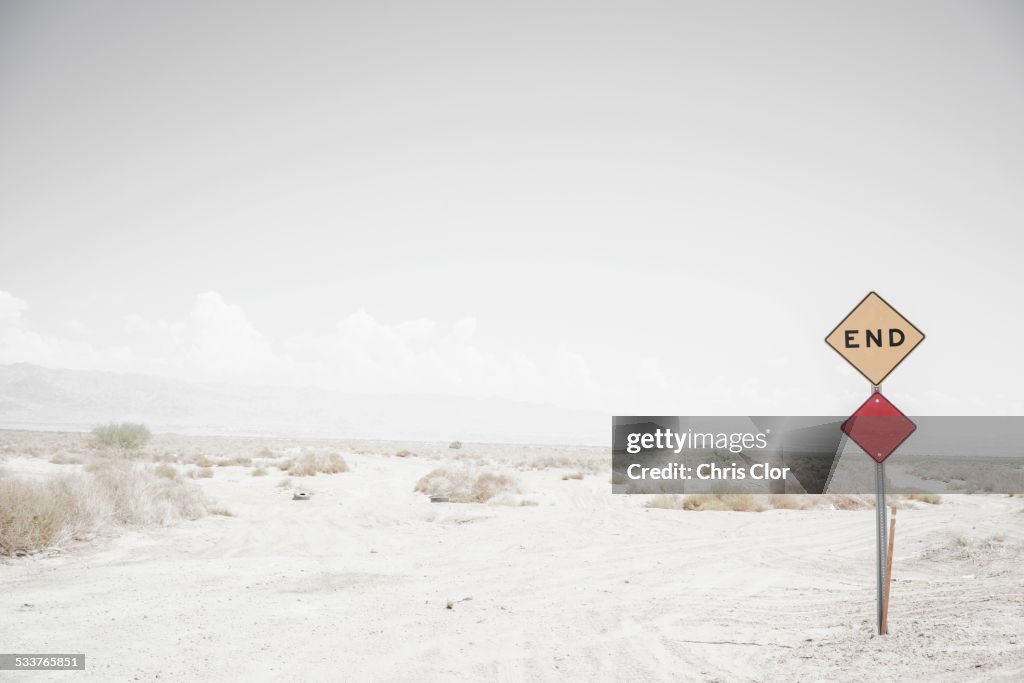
[0,0,1024,415]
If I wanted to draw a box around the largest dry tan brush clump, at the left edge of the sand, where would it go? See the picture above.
[0,462,207,555]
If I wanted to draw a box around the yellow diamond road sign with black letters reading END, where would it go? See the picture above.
[825,292,925,386]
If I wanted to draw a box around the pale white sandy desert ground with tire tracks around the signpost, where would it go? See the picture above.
[0,448,1024,681]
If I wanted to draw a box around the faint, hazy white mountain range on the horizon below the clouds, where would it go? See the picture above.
[0,364,610,445]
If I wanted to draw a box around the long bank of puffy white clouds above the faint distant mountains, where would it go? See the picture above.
[0,292,599,405]
